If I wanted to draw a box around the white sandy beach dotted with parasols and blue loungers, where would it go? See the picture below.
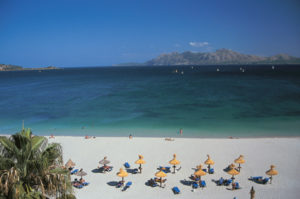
[49,136,300,199]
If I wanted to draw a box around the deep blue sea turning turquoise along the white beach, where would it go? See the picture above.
[0,65,300,137]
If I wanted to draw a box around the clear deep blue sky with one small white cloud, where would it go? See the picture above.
[0,0,300,67]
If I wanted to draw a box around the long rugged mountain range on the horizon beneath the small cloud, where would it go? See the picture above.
[118,48,300,66]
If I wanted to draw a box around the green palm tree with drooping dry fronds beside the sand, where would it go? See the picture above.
[0,129,72,199]
